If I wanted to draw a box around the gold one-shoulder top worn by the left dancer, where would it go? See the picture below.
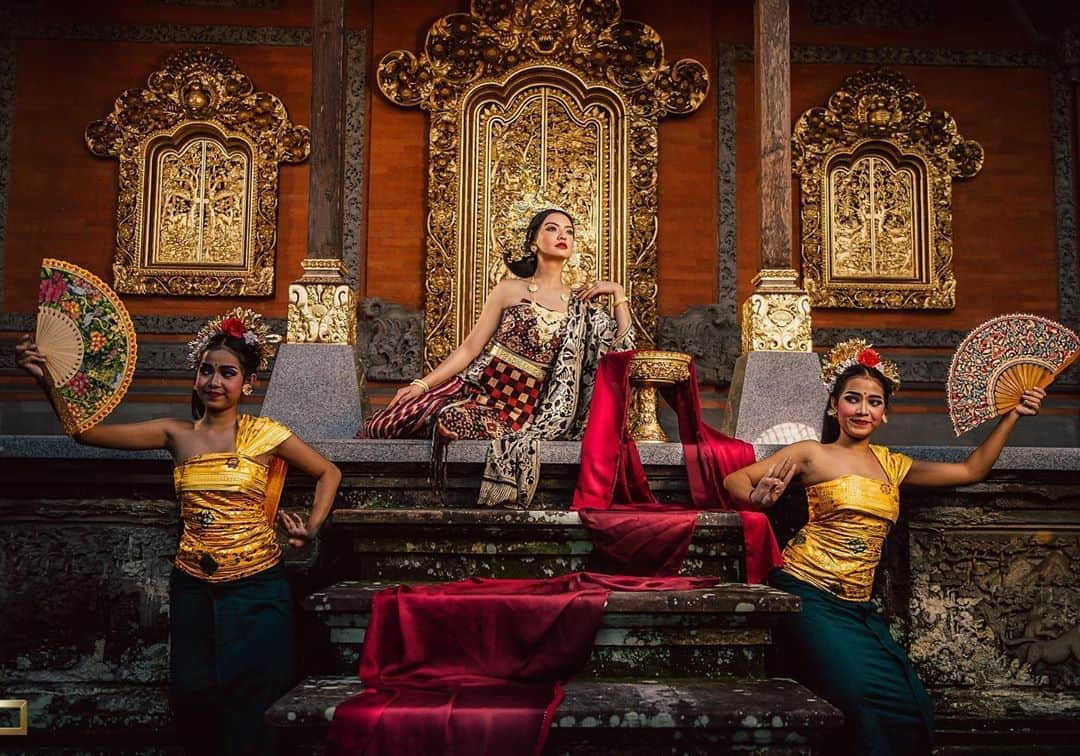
[173,415,293,582]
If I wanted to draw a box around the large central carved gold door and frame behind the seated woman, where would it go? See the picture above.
[377,0,708,368]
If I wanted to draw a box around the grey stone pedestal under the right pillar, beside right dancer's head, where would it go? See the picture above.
[724,352,828,444]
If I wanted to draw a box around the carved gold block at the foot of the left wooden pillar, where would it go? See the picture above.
[288,257,356,345]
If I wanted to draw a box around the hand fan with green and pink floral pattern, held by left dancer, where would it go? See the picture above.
[36,259,136,435]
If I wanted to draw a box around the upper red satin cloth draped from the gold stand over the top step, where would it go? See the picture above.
[571,351,782,583]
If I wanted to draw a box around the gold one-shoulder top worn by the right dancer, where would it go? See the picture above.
[784,445,912,602]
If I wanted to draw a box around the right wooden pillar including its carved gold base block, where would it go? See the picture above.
[742,0,811,353]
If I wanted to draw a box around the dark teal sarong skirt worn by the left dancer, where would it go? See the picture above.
[168,565,294,756]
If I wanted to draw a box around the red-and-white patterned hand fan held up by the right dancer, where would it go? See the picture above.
[946,313,1080,435]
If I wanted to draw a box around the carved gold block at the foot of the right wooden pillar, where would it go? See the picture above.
[742,268,813,353]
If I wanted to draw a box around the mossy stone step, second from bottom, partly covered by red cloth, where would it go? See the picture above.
[303,581,801,679]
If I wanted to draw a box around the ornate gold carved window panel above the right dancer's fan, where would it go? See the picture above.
[792,69,983,309]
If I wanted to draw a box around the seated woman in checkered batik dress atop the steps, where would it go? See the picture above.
[360,208,633,508]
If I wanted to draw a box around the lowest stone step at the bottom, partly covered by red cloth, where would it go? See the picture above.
[267,676,842,756]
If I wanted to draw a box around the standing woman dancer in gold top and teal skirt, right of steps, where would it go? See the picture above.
[724,339,1045,756]
